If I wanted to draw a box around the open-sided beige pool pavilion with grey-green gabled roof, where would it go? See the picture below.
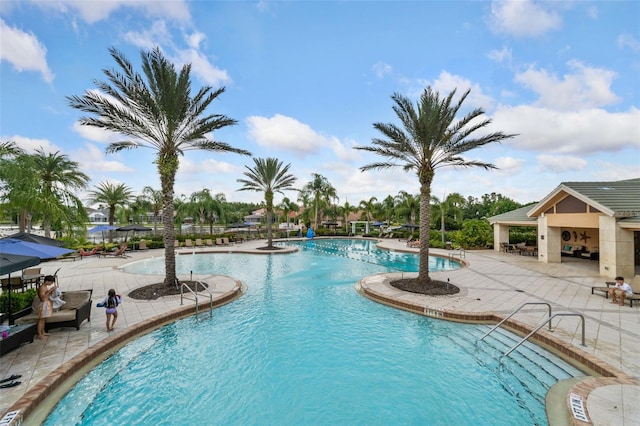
[489,178,640,279]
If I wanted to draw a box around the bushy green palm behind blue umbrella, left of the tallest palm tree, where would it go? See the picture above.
[29,149,89,237]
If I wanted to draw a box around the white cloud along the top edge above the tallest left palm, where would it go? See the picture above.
[36,0,191,24]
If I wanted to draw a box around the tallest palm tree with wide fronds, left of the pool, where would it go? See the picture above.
[67,47,251,285]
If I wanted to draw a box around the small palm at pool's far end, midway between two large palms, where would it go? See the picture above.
[238,158,296,249]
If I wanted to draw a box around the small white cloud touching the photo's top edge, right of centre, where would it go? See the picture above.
[489,0,562,37]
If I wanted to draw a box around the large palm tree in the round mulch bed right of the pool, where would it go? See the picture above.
[356,87,516,291]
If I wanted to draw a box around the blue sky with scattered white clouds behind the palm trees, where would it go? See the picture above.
[0,0,640,205]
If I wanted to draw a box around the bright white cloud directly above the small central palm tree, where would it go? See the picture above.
[246,114,357,160]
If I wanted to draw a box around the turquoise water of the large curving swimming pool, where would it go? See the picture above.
[45,240,582,425]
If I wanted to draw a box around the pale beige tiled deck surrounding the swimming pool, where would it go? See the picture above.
[0,239,640,425]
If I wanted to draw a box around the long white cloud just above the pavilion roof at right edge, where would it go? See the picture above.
[491,105,640,155]
